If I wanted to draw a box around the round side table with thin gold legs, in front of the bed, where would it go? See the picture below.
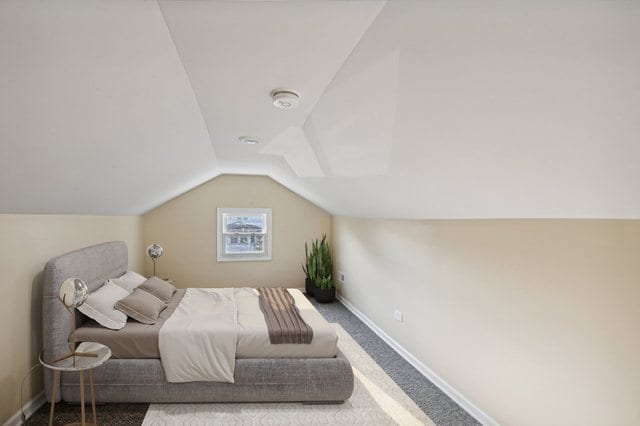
[40,342,111,426]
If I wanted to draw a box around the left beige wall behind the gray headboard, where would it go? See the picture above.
[0,214,143,423]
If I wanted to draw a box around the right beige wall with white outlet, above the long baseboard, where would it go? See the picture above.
[332,217,640,425]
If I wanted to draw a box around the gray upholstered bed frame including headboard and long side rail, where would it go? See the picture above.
[42,241,353,403]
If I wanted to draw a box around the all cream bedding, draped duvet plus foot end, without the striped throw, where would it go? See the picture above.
[158,288,338,383]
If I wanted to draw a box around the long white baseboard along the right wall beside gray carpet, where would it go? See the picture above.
[336,294,499,426]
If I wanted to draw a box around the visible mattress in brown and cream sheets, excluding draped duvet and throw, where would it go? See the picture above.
[75,288,338,359]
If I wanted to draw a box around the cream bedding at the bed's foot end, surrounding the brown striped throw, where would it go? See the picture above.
[234,288,338,358]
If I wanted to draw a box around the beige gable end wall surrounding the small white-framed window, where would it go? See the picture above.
[144,175,331,287]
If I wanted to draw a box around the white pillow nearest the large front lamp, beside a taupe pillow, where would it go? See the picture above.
[78,281,129,330]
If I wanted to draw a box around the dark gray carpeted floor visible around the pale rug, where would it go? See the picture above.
[27,300,479,426]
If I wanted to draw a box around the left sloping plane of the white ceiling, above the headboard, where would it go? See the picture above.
[0,1,216,214]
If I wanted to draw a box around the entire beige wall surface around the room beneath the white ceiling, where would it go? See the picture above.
[7,185,640,425]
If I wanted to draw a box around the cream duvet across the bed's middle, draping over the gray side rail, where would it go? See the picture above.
[158,288,238,383]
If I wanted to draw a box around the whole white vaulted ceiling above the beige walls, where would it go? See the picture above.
[0,0,640,218]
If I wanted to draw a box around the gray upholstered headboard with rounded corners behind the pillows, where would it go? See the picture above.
[42,241,129,402]
